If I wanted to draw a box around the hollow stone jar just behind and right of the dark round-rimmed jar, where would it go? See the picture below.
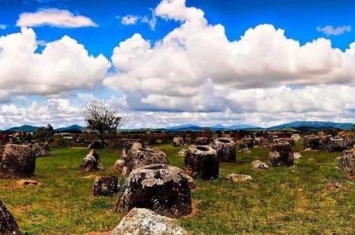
[211,138,237,162]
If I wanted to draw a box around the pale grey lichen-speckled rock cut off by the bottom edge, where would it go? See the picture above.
[111,208,188,235]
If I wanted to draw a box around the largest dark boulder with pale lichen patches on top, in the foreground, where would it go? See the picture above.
[116,164,192,218]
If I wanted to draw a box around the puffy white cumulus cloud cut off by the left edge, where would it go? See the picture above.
[0,28,110,98]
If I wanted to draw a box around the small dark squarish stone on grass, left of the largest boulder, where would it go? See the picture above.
[92,176,118,197]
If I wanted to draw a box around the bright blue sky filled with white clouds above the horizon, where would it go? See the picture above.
[0,0,355,129]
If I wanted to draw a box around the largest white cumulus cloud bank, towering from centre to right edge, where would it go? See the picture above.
[104,0,355,112]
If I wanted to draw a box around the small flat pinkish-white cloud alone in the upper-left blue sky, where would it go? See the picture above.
[16,8,98,28]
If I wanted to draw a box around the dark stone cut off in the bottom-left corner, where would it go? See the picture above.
[0,199,21,235]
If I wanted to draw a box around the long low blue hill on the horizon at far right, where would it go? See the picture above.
[268,121,353,131]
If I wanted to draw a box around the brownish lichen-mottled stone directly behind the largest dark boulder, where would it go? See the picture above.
[121,142,169,177]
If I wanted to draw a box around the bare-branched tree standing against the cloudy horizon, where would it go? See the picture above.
[81,100,126,144]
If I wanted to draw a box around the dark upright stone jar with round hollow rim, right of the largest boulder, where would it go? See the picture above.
[184,145,219,180]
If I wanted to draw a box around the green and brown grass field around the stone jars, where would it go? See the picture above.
[0,145,355,234]
